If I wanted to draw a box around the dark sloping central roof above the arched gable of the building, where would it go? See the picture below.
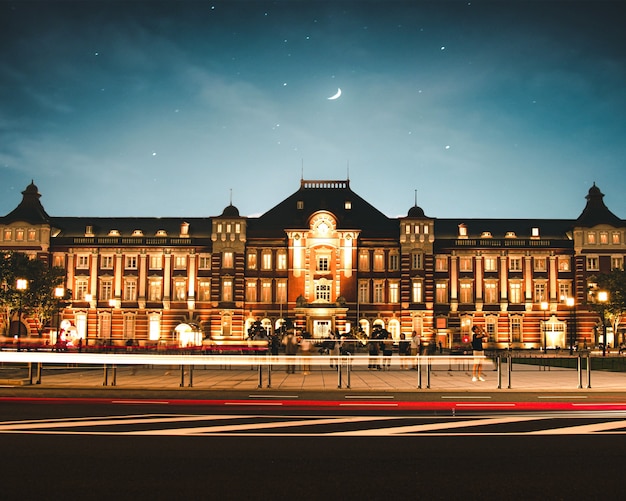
[248,180,399,238]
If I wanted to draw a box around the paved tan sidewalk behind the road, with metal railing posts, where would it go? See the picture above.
[0,359,626,392]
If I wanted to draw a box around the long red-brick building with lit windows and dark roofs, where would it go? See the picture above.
[0,180,626,348]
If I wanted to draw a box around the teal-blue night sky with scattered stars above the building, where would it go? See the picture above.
[0,0,626,219]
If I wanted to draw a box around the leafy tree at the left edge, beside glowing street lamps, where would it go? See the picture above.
[0,251,68,335]
